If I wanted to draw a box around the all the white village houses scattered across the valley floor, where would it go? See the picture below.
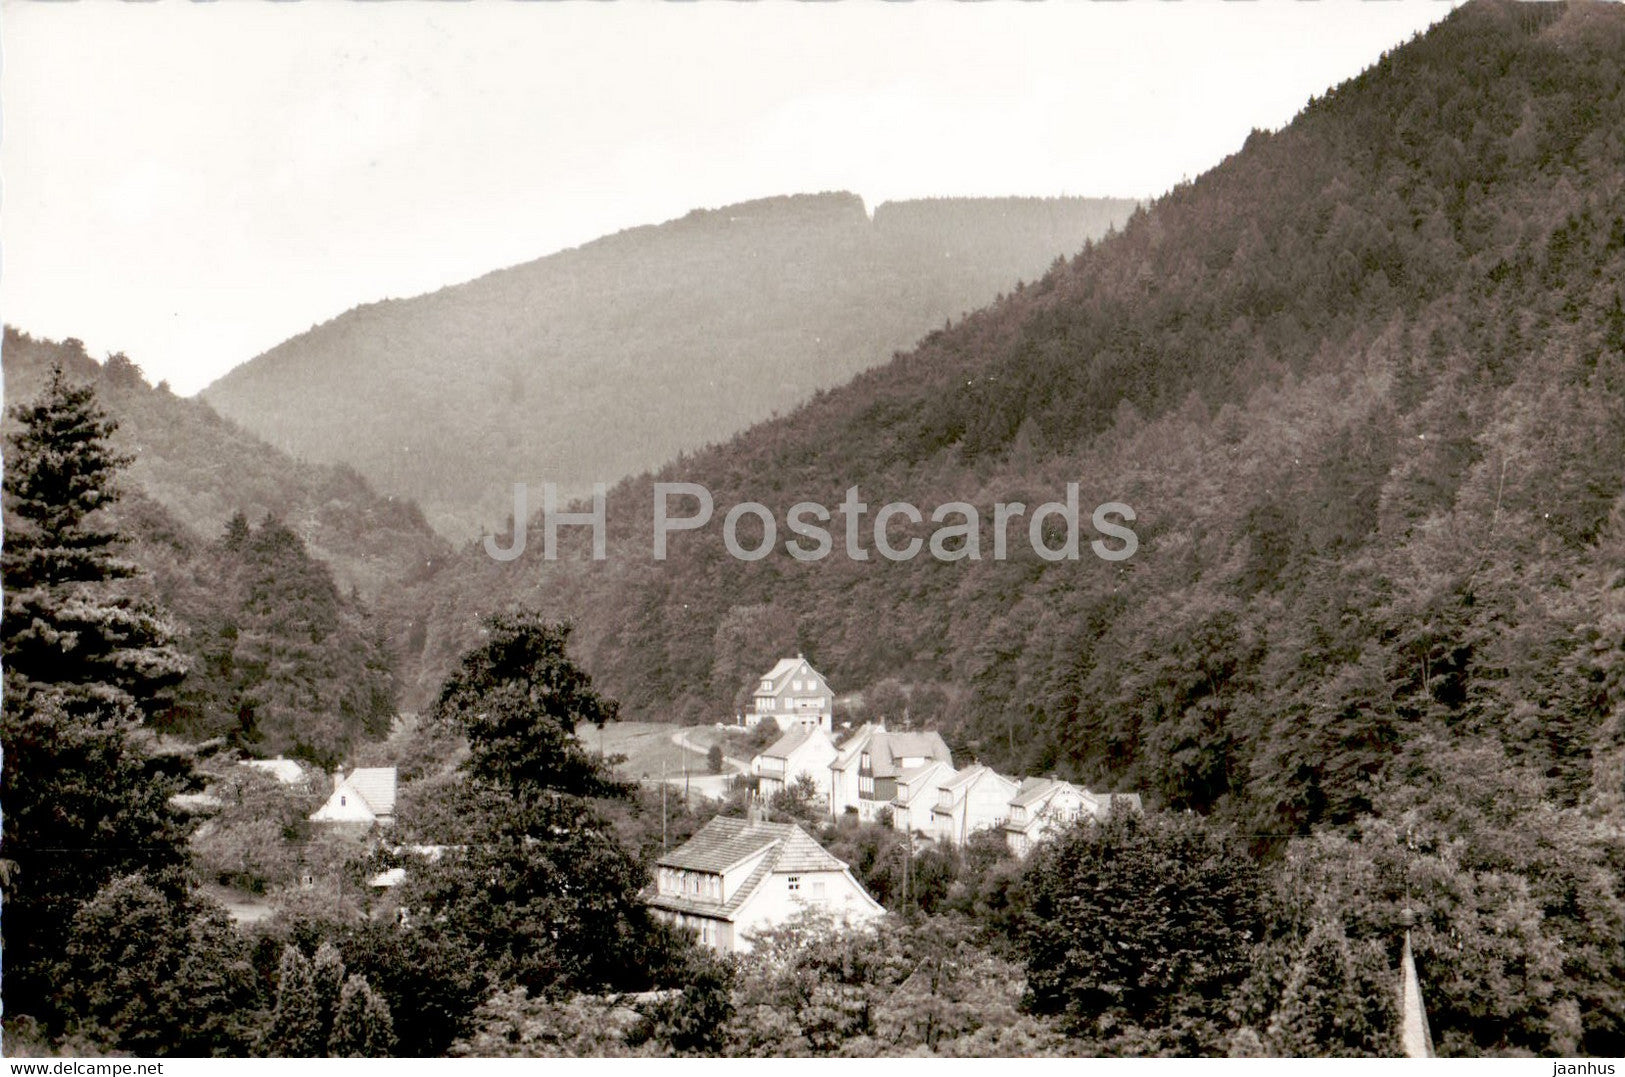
[171,655,1141,954]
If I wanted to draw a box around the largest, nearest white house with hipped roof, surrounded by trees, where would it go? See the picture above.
[648,815,884,954]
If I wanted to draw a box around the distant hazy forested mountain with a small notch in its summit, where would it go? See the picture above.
[203,193,1134,539]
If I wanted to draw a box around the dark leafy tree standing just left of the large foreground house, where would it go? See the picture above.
[405,614,689,993]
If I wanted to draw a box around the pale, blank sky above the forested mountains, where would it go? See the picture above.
[0,0,1451,393]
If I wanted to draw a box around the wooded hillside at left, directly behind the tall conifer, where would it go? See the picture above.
[3,327,425,767]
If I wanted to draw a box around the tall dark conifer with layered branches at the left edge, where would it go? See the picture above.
[0,372,187,1022]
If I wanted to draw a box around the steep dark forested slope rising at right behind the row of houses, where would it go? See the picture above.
[408,3,1625,833]
